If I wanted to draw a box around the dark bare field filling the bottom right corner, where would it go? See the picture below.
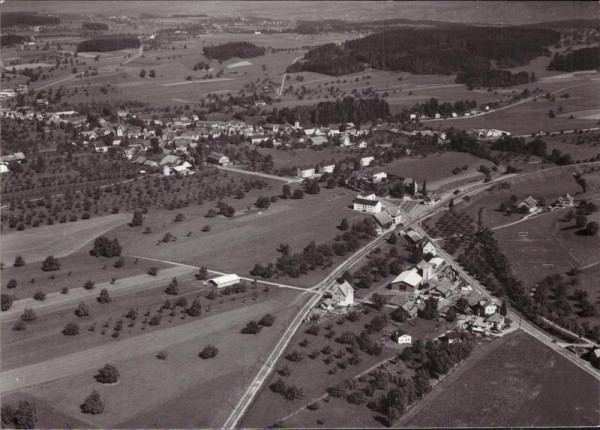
[402,332,600,427]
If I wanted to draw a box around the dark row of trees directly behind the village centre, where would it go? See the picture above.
[266,97,390,125]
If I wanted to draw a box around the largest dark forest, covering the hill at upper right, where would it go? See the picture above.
[290,26,560,75]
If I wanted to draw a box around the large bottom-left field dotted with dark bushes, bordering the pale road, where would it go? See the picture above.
[2,290,304,428]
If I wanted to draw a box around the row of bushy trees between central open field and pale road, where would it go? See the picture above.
[250,219,377,279]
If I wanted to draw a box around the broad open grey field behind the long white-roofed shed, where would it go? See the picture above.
[111,185,365,286]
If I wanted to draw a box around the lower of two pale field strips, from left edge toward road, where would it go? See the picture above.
[0,300,284,393]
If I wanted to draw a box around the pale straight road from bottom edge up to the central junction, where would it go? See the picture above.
[223,223,392,429]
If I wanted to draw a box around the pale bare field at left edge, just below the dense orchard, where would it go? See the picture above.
[0,214,131,266]
